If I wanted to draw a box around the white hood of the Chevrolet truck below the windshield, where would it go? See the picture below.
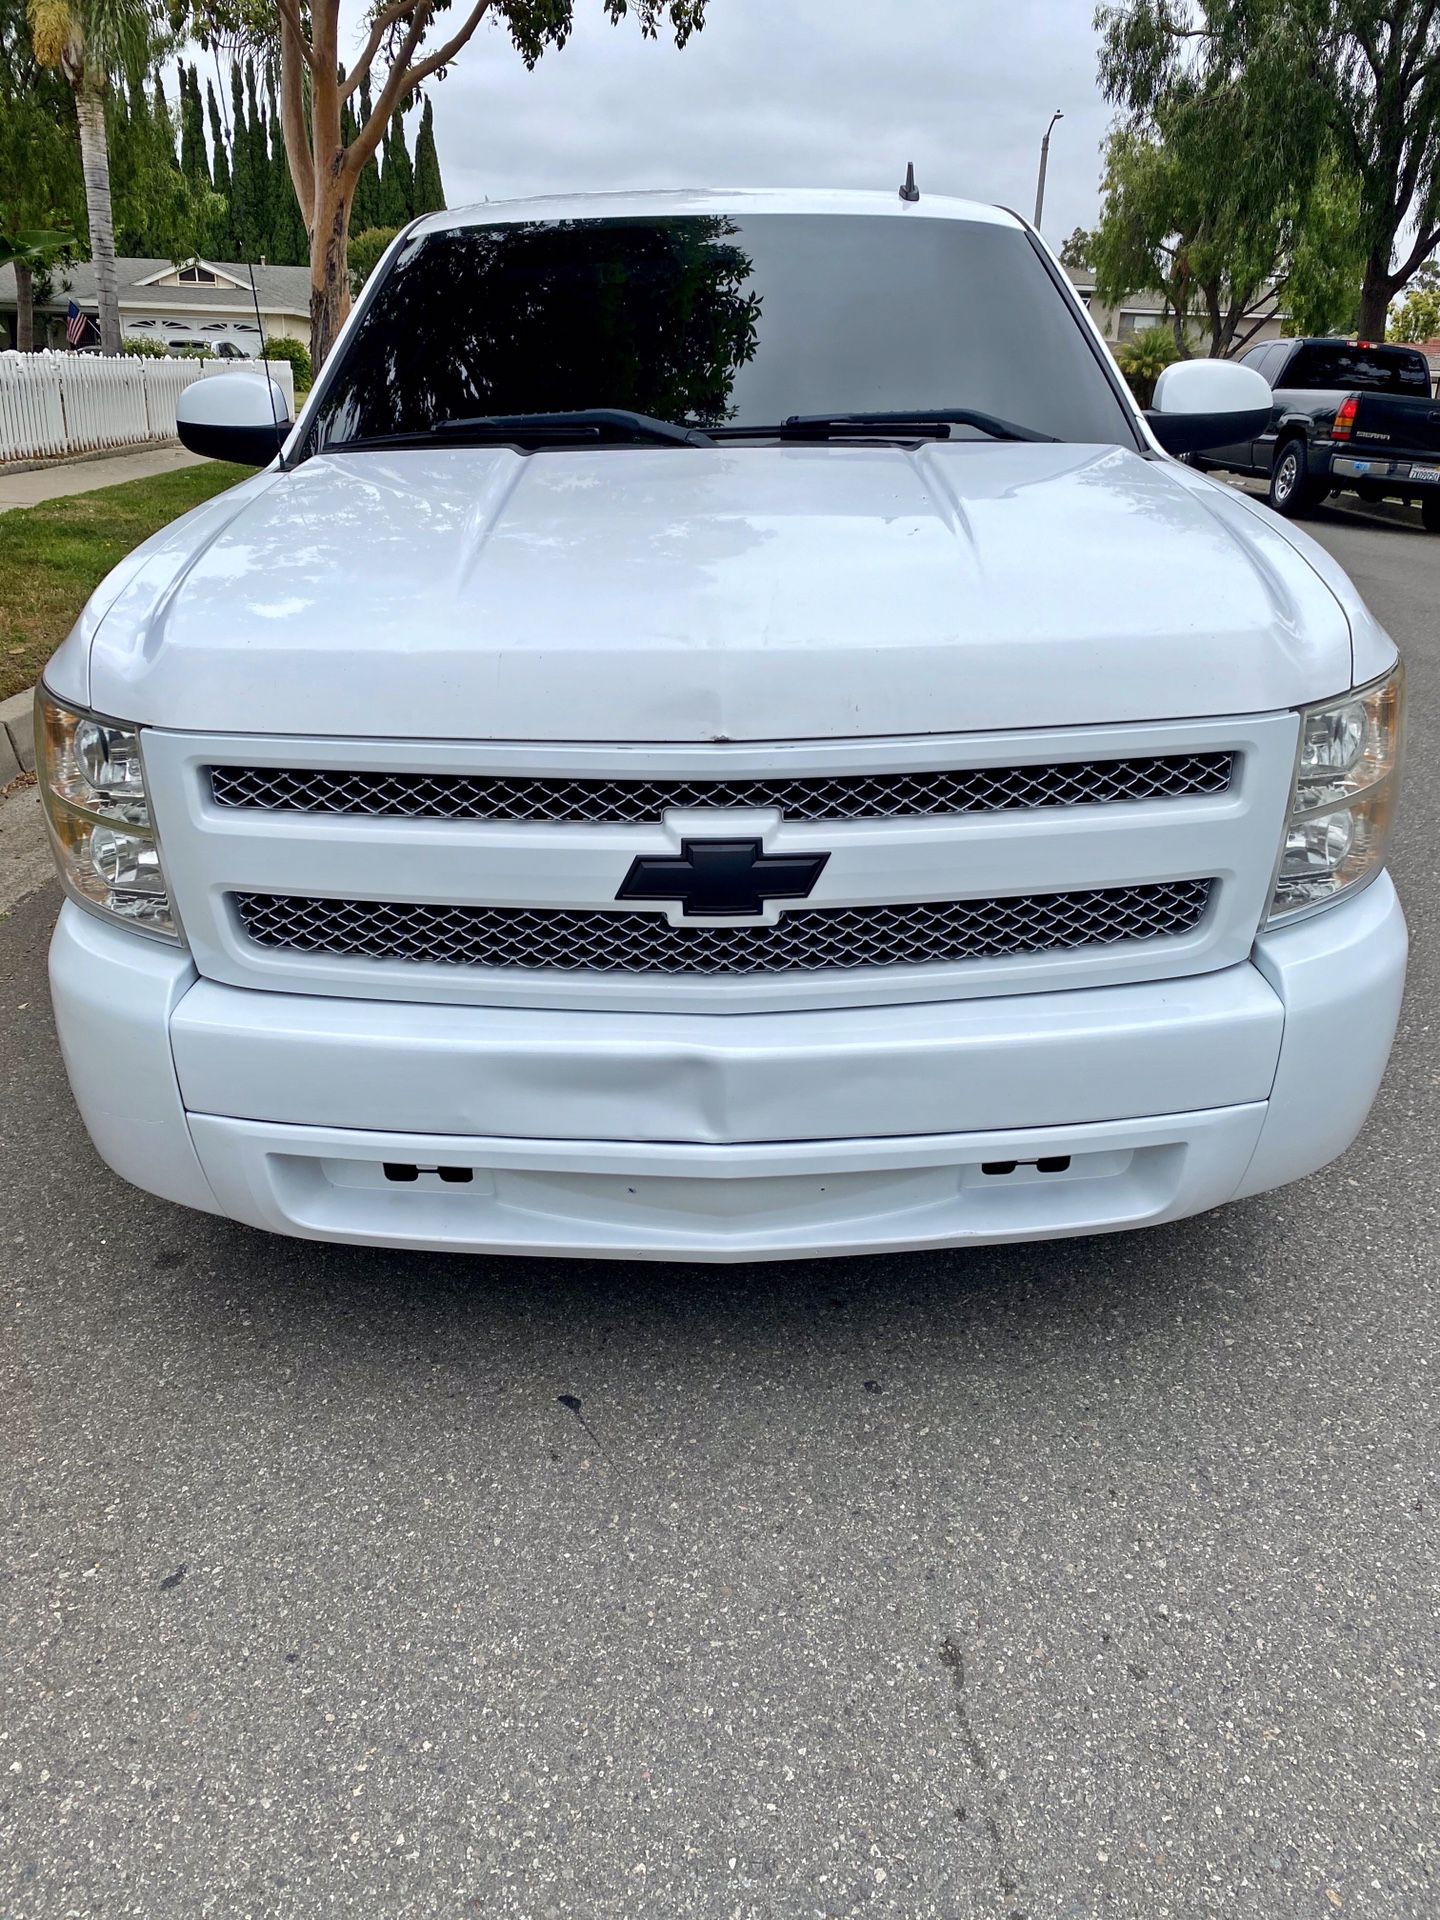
[76,442,1352,741]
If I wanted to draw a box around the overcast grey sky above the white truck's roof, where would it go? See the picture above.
[422,0,1110,242]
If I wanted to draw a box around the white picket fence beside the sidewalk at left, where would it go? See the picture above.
[0,353,294,461]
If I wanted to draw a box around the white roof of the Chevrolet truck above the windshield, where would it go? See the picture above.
[411,184,1023,234]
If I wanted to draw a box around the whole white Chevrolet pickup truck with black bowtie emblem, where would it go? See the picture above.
[38,192,1405,1260]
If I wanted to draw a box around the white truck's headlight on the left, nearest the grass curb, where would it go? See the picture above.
[35,687,180,945]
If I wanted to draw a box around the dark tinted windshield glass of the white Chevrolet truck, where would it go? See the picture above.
[307,213,1135,447]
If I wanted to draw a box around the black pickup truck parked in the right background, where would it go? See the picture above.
[1202,340,1440,534]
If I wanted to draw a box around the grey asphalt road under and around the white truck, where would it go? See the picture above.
[0,511,1440,1920]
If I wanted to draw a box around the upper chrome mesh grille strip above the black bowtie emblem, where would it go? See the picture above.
[209,753,1235,826]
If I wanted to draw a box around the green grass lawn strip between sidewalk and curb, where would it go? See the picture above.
[0,461,250,701]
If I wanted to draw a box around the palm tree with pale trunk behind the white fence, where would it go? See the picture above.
[27,0,156,353]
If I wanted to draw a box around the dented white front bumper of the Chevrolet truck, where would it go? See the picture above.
[50,876,1405,1260]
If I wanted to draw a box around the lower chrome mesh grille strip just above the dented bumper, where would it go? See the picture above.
[232,879,1213,973]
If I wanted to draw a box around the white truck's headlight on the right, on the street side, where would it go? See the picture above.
[1269,664,1405,925]
